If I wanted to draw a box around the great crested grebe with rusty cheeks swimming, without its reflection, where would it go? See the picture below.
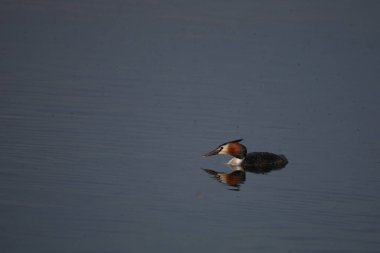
[204,139,288,170]
